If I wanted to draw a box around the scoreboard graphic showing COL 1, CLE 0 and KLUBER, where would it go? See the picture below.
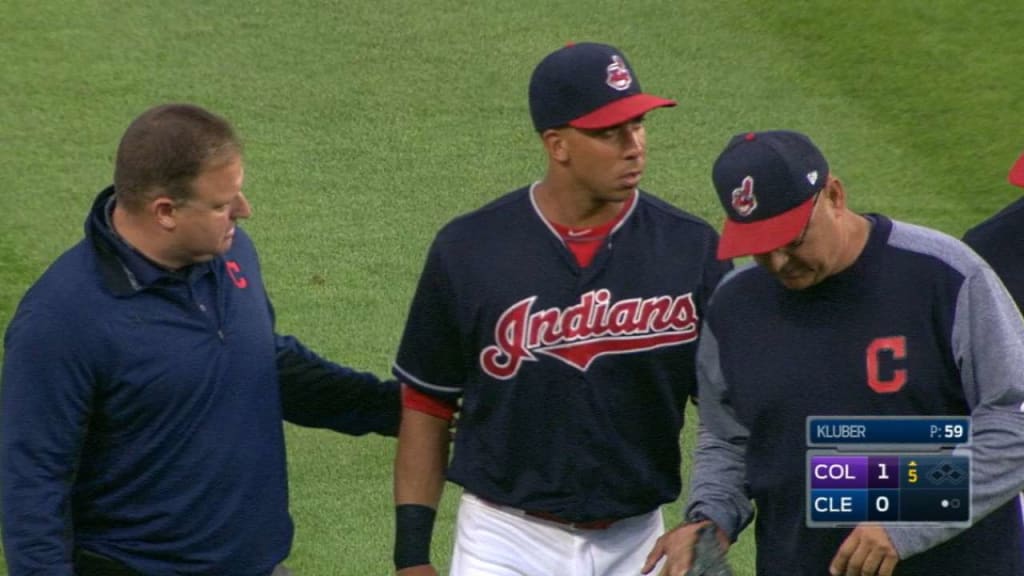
[807,416,971,528]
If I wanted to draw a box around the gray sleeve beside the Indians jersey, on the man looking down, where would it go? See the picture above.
[686,323,754,541]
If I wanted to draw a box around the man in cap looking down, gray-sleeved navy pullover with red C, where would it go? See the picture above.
[651,131,1024,576]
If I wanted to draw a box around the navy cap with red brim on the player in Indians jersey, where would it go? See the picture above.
[529,42,676,132]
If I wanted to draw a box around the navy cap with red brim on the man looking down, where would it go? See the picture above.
[712,130,828,260]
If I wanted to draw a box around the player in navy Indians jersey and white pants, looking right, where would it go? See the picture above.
[394,43,729,576]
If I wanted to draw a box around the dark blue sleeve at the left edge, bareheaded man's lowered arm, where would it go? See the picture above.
[0,308,88,576]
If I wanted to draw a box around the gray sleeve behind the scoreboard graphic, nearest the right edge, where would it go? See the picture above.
[887,264,1024,559]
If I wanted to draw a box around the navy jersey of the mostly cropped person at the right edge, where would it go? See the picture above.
[964,193,1024,308]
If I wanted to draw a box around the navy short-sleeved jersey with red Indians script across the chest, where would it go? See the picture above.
[394,188,728,522]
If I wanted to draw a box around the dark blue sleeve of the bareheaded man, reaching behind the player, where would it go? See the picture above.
[274,334,401,436]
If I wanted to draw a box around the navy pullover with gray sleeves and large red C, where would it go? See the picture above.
[691,216,1024,576]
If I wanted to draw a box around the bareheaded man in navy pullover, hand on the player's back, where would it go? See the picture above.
[0,105,399,576]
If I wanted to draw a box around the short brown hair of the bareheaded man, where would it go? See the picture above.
[114,104,242,209]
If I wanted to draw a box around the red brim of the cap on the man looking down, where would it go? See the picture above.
[718,196,814,260]
